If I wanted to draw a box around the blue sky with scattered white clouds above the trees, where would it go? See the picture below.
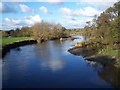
[0,0,117,30]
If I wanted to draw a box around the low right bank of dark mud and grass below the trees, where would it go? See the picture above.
[68,47,120,67]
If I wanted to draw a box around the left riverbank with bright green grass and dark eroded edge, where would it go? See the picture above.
[1,37,37,57]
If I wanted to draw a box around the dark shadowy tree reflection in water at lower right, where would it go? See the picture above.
[87,61,120,88]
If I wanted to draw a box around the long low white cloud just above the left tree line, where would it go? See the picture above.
[0,15,42,30]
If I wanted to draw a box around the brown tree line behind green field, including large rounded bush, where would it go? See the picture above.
[2,21,67,42]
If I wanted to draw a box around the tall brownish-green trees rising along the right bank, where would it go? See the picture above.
[71,1,120,49]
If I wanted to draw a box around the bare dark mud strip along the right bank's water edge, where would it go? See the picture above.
[68,47,117,65]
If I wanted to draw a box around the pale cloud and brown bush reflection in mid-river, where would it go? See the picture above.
[34,41,64,71]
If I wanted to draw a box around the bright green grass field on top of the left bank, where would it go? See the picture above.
[0,37,33,46]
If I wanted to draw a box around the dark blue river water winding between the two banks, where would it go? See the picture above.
[2,36,119,88]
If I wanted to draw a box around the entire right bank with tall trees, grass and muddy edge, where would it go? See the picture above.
[69,1,120,67]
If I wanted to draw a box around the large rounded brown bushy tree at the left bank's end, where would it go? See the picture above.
[32,21,65,43]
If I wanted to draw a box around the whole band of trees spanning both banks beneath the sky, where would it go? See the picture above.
[2,1,120,47]
